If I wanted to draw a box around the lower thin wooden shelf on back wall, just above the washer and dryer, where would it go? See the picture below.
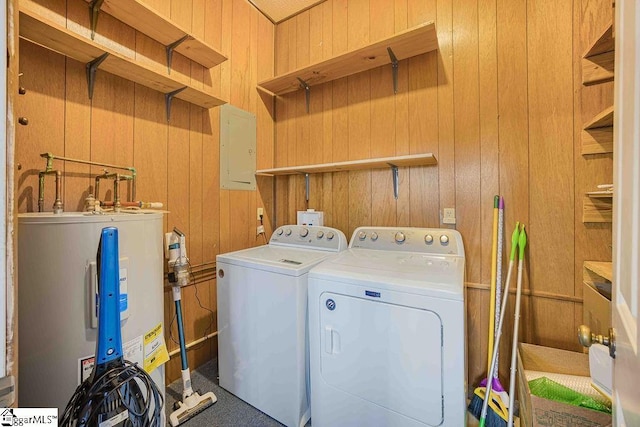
[256,153,437,176]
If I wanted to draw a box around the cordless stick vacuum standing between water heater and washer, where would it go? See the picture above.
[165,227,218,427]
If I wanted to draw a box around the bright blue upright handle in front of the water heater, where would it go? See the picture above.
[96,227,122,365]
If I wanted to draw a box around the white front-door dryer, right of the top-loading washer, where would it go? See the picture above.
[309,227,467,427]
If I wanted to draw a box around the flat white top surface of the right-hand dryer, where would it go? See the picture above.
[309,249,464,300]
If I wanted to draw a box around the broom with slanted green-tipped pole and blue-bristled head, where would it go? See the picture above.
[469,223,520,427]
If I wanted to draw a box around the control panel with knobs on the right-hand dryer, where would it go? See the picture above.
[349,227,464,256]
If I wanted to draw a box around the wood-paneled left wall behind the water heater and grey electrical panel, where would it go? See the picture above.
[16,0,274,381]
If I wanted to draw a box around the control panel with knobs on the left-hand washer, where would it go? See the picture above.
[269,225,347,252]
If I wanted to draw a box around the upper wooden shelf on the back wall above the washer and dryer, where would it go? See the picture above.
[258,22,438,95]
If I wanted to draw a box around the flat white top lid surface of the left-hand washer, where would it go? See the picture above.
[216,245,335,276]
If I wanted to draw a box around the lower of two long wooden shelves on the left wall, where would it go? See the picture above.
[20,1,225,108]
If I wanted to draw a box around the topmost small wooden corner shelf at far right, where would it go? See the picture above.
[582,21,615,85]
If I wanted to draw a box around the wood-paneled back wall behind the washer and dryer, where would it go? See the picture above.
[274,0,612,387]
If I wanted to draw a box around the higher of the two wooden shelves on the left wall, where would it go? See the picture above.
[86,0,227,68]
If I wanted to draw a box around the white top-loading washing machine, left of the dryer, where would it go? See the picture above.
[216,225,347,427]
